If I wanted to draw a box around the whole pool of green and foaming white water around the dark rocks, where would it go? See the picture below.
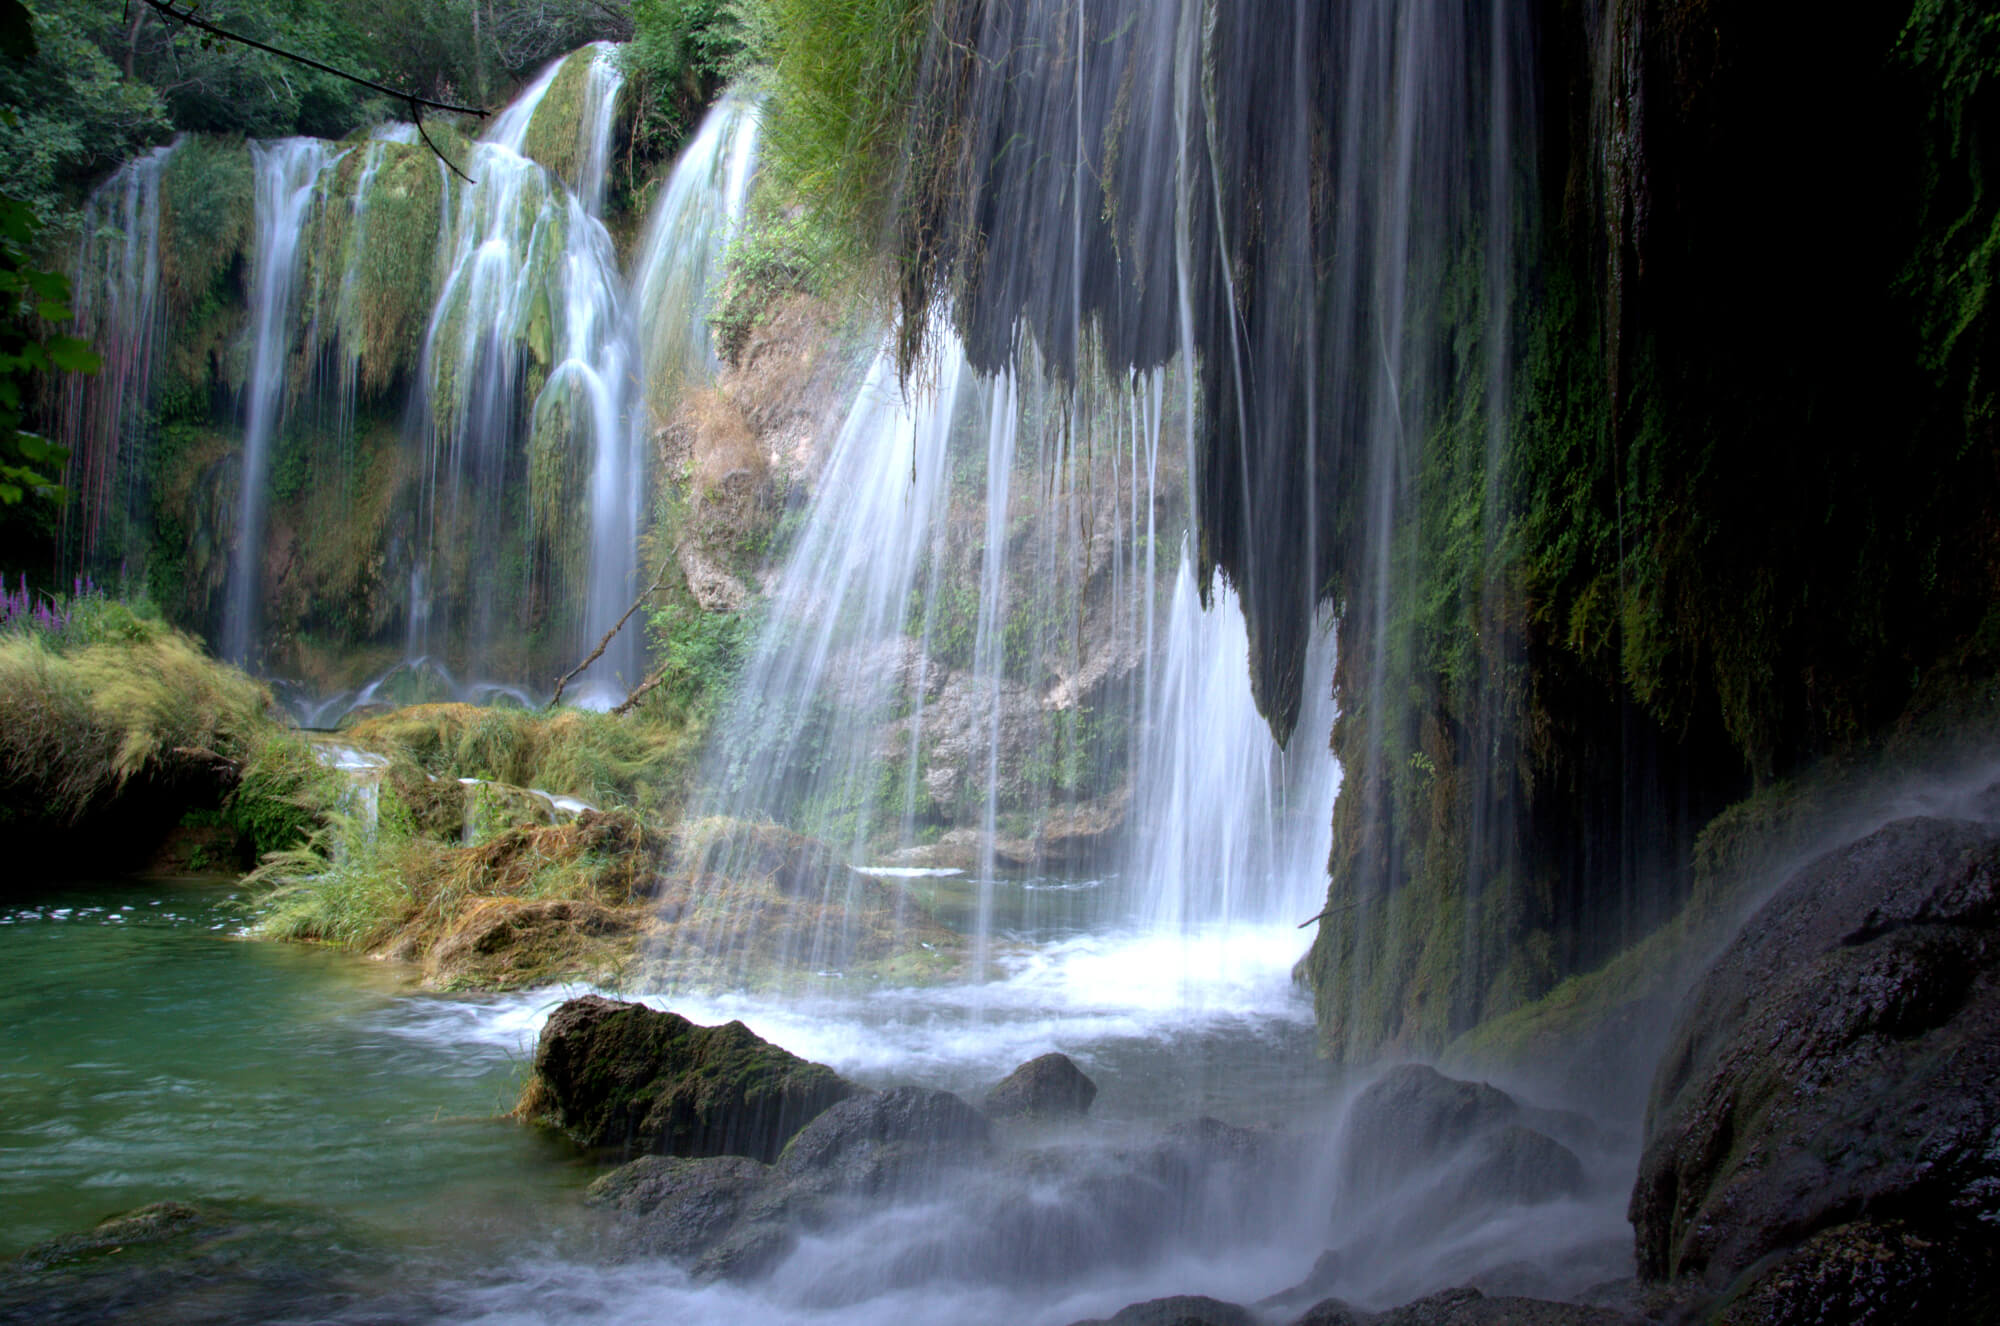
[0,880,1602,1326]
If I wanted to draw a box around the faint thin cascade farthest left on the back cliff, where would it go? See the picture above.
[58,140,180,566]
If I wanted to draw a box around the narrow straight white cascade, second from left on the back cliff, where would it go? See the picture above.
[222,138,334,664]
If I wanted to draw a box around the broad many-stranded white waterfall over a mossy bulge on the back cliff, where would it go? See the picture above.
[408,48,636,676]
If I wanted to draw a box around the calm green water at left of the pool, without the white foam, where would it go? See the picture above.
[0,882,594,1264]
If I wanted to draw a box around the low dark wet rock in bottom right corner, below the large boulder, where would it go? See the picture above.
[1710,1220,2000,1326]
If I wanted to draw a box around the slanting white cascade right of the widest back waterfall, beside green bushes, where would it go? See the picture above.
[632,92,760,416]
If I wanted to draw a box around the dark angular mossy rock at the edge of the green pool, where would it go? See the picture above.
[520,994,860,1162]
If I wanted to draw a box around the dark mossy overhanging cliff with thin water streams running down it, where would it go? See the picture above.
[770,0,2000,1056]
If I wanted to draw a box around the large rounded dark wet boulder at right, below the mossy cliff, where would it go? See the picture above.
[1630,818,2000,1296]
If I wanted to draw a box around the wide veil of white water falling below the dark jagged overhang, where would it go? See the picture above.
[686,314,1336,980]
